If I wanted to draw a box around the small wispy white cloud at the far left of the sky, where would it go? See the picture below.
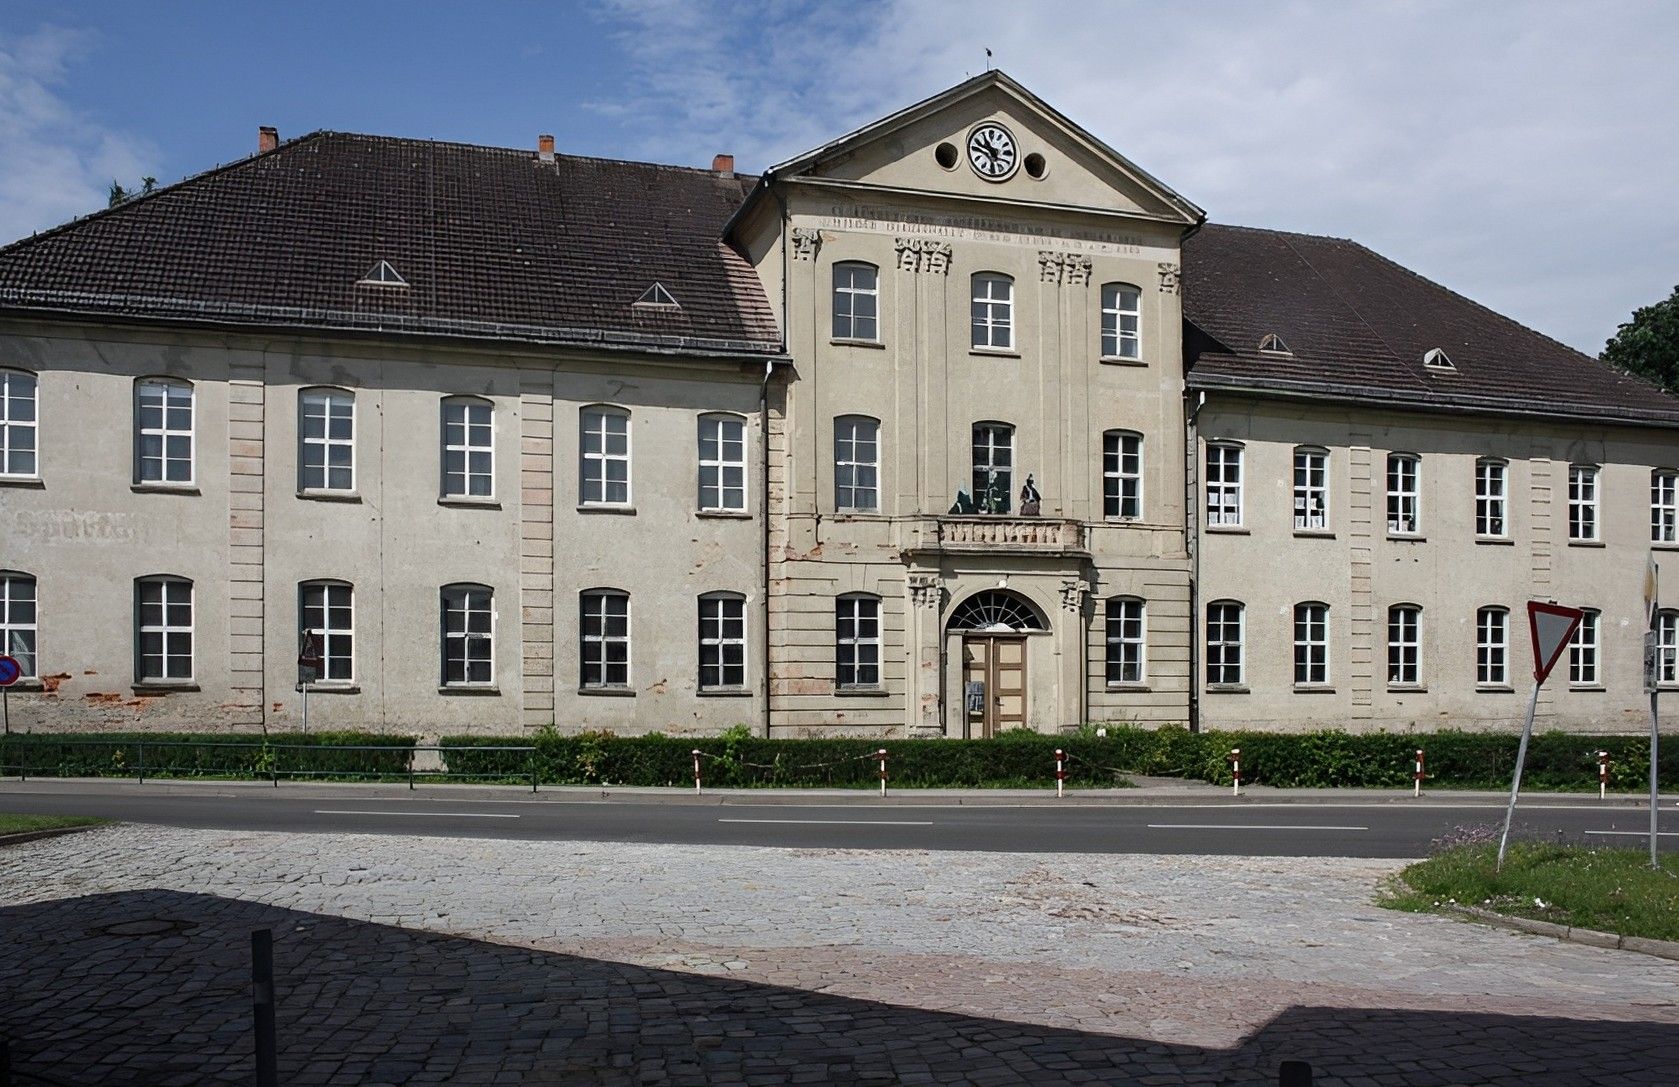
[0,27,154,242]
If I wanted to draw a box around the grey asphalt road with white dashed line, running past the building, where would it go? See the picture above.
[0,781,1679,859]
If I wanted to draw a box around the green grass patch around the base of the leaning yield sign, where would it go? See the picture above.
[1378,842,1679,941]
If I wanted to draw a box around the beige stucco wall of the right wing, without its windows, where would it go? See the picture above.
[1195,393,1679,733]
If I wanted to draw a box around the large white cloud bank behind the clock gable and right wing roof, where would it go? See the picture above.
[603,0,1679,353]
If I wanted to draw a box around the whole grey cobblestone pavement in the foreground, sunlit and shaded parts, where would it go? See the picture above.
[0,827,1679,1087]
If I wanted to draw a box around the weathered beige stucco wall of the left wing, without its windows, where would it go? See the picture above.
[0,317,762,736]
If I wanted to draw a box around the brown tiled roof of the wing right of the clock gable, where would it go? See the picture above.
[1182,223,1679,425]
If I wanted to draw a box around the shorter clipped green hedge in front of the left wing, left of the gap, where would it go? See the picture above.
[0,733,415,778]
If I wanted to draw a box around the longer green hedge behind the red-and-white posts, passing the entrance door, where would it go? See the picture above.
[442,726,1679,791]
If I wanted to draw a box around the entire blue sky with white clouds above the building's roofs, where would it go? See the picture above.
[0,0,1679,353]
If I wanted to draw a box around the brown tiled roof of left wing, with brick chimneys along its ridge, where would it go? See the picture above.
[0,133,781,354]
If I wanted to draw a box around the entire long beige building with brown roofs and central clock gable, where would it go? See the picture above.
[0,72,1679,738]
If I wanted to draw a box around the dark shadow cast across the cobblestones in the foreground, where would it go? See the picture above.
[0,890,1679,1087]
